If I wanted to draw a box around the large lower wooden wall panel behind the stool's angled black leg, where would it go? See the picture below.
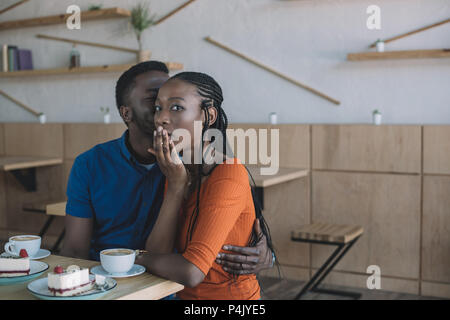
[312,172,421,279]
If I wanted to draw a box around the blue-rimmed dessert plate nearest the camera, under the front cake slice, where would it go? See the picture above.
[27,274,117,300]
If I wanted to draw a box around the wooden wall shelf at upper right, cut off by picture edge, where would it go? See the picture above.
[347,49,450,61]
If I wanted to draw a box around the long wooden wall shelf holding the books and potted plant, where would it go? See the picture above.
[0,62,183,78]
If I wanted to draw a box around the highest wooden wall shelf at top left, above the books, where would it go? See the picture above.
[0,8,131,31]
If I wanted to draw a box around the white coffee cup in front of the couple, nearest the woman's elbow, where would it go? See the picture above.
[100,248,136,273]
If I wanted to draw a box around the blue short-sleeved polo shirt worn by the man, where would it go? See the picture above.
[66,131,165,261]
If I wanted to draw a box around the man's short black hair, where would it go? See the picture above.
[116,61,169,109]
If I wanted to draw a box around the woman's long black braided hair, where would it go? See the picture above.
[170,72,274,272]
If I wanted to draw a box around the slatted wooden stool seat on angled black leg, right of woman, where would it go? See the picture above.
[291,222,364,243]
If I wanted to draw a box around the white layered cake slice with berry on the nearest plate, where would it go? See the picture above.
[48,265,95,297]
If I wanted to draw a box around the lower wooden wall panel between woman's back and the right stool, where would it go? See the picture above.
[263,176,309,267]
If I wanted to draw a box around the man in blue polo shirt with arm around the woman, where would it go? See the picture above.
[61,61,273,274]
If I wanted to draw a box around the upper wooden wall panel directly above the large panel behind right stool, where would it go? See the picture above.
[312,125,421,173]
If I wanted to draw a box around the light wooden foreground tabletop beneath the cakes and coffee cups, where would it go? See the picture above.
[0,255,184,300]
